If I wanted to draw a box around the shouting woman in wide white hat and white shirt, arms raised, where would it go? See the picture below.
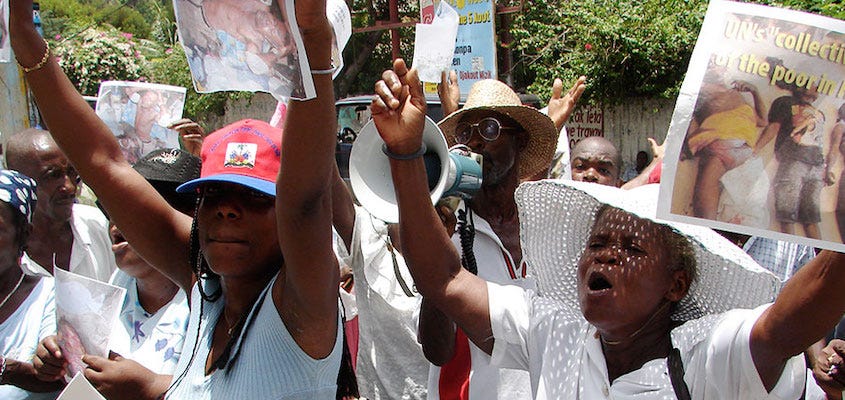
[373,57,845,400]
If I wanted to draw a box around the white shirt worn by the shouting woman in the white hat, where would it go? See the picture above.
[487,283,806,400]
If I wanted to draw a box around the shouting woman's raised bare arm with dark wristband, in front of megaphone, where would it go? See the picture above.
[372,59,493,352]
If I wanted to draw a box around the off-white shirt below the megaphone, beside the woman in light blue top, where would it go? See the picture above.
[335,206,429,400]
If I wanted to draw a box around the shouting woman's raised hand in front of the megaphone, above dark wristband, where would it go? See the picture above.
[370,58,425,154]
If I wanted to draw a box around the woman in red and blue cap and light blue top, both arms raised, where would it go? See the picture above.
[11,0,342,399]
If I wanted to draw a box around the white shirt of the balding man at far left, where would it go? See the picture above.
[21,204,117,282]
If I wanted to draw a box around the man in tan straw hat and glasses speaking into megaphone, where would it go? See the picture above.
[382,61,584,399]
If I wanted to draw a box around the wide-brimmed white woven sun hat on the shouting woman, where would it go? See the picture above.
[516,180,781,321]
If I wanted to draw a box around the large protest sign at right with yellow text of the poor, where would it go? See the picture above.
[658,1,845,251]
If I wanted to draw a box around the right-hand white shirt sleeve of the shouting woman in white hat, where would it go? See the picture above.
[706,304,806,399]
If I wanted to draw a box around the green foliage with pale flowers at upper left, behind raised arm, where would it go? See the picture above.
[40,0,247,121]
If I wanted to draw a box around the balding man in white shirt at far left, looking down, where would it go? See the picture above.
[6,129,117,282]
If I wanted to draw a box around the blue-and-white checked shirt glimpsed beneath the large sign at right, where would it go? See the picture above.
[742,236,816,282]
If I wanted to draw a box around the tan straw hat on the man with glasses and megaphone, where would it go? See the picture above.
[438,79,558,179]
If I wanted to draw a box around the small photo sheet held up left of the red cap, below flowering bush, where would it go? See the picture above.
[97,82,186,163]
